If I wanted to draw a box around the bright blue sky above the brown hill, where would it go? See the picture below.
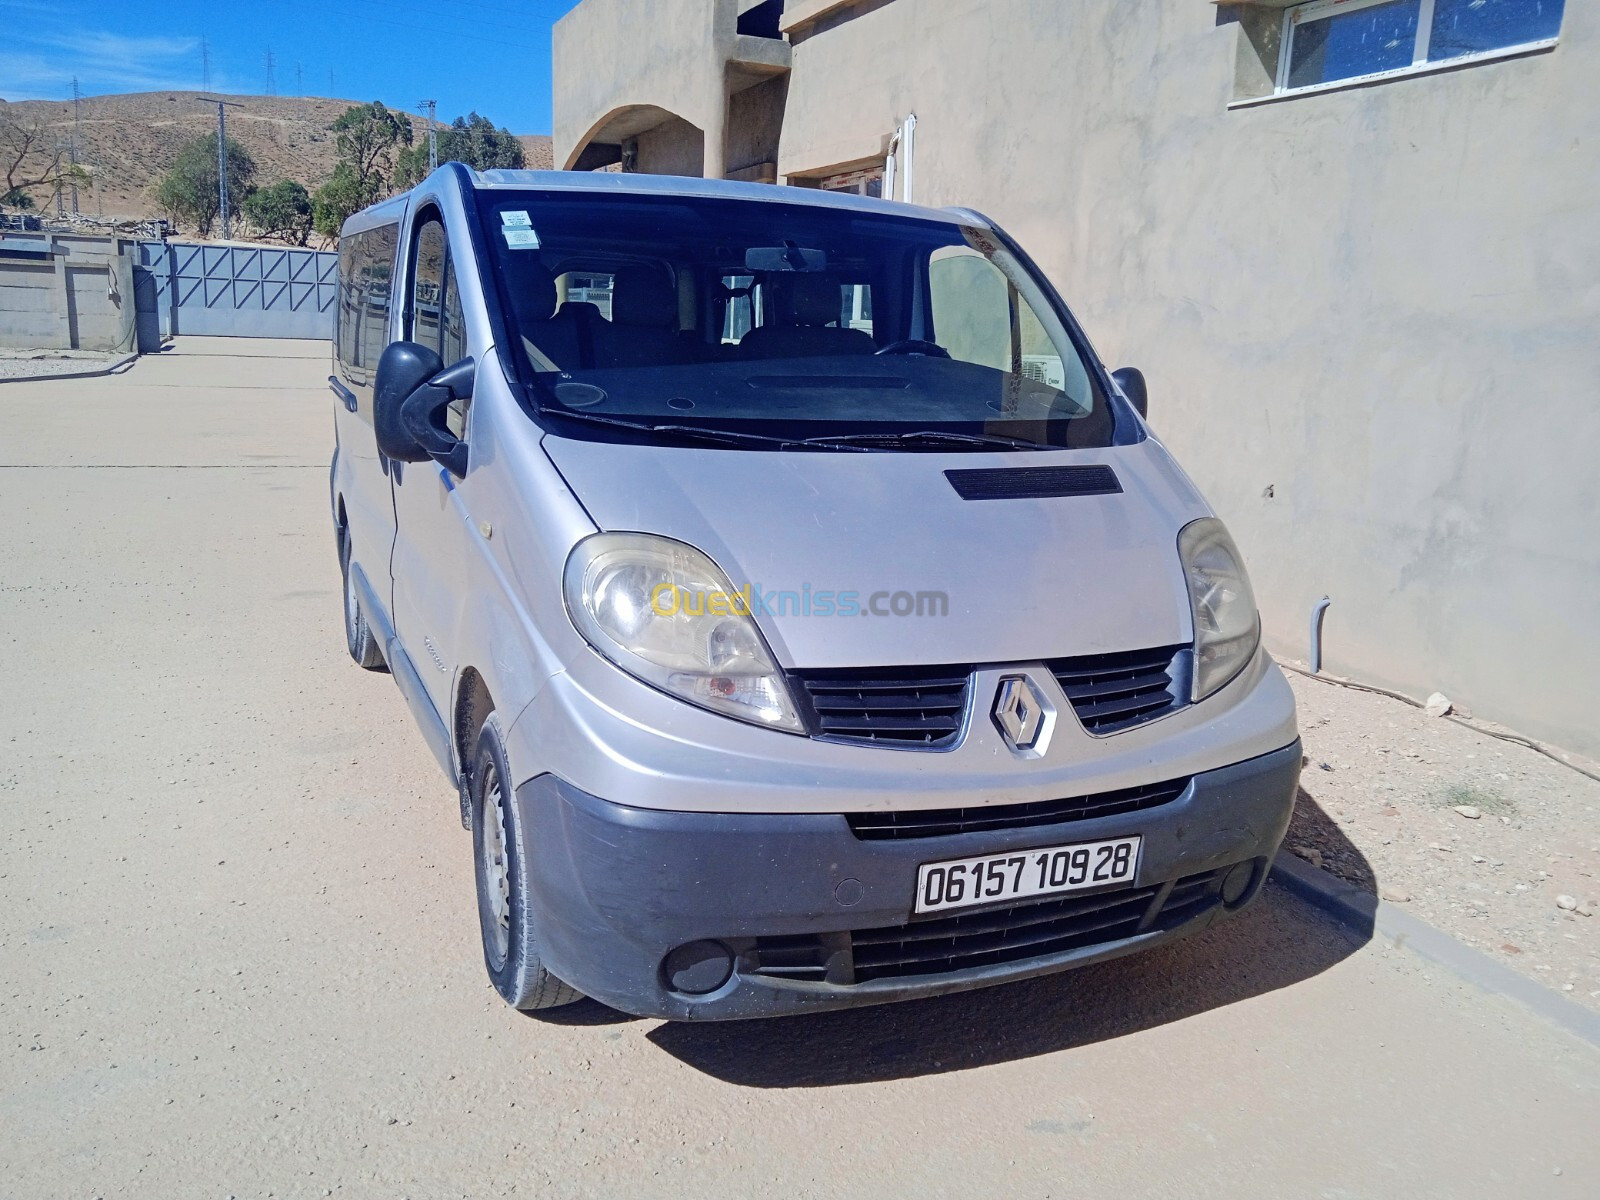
[0,0,576,133]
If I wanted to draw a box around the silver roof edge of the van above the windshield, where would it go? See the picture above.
[346,163,989,232]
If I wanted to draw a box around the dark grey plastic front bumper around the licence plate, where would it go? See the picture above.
[517,741,1301,1021]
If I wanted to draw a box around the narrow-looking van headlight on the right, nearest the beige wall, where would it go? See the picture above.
[1178,517,1261,701]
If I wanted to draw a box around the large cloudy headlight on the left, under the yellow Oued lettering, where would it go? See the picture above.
[563,533,805,733]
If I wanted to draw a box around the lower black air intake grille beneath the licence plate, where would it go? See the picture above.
[741,867,1227,984]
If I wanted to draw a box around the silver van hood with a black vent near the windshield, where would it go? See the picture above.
[542,437,1210,667]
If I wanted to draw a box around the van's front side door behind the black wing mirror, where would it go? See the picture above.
[392,208,477,725]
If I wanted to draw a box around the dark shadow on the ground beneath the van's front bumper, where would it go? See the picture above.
[541,790,1373,1088]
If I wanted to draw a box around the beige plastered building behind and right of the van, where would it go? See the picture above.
[554,0,1600,754]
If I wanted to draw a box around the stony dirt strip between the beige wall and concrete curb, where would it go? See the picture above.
[1285,674,1600,1010]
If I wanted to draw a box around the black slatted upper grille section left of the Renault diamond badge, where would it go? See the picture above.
[795,667,973,749]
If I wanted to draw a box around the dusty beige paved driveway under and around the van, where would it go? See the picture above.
[0,339,1600,1200]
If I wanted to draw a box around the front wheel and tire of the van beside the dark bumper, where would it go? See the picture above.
[467,714,582,1011]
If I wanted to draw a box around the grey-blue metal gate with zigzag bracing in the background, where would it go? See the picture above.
[134,242,339,350]
